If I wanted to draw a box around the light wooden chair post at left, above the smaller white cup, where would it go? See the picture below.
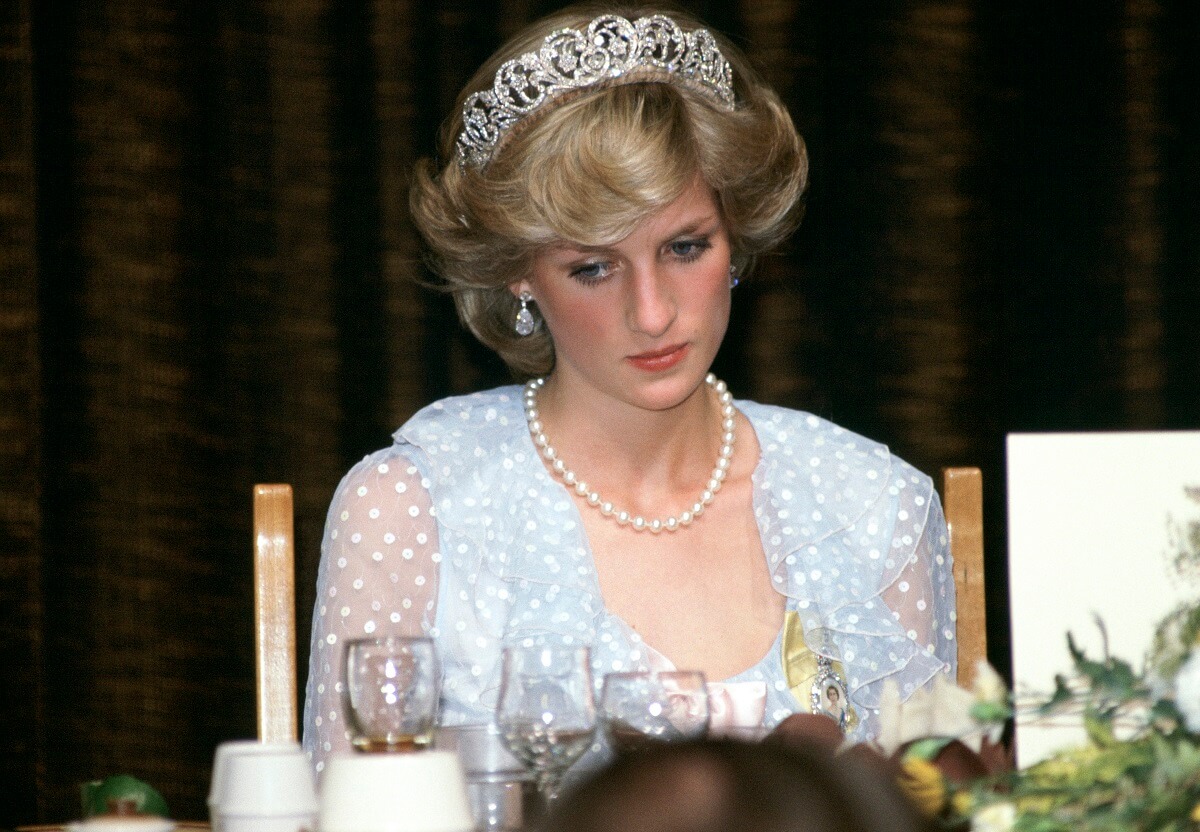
[254,485,299,742]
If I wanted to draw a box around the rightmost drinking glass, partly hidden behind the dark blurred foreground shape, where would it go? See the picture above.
[600,670,709,752]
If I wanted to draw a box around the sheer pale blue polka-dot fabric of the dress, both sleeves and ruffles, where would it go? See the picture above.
[304,387,955,772]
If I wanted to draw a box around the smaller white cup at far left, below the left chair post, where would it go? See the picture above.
[209,741,318,832]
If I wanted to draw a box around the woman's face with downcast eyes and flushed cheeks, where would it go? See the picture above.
[512,178,730,409]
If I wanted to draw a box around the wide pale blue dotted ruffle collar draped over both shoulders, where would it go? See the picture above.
[395,385,941,706]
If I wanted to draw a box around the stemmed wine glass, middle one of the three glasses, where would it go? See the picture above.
[496,646,596,803]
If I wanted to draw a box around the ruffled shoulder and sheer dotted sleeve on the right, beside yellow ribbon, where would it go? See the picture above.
[739,402,955,740]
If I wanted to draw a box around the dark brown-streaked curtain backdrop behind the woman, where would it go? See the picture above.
[0,0,1200,826]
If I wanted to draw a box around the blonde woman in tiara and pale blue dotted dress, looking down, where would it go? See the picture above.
[305,7,954,771]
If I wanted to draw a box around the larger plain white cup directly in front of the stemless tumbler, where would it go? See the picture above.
[317,750,474,832]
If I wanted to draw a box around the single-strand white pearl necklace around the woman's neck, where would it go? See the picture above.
[524,373,737,534]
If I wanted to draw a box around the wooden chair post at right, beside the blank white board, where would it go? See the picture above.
[942,468,988,688]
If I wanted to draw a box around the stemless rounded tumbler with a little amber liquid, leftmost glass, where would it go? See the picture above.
[344,636,440,752]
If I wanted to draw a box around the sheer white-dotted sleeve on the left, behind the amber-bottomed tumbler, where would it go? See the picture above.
[304,447,442,773]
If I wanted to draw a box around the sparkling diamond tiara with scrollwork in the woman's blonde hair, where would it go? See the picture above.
[458,14,734,168]
